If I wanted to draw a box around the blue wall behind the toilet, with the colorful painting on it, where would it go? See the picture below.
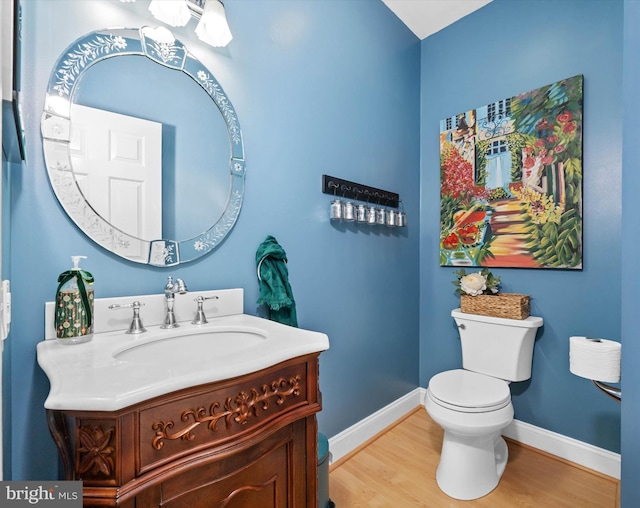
[420,0,623,452]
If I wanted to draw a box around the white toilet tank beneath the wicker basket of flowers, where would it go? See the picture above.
[451,309,543,381]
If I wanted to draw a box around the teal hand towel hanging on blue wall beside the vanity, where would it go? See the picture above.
[256,235,298,327]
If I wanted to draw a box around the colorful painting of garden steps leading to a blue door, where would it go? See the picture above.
[440,75,583,269]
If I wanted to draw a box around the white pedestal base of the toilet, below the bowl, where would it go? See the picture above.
[436,431,509,501]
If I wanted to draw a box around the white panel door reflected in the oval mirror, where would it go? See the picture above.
[70,104,162,254]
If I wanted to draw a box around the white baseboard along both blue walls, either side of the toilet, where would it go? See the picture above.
[329,388,620,480]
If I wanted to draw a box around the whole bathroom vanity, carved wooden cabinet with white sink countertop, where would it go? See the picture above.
[38,290,329,508]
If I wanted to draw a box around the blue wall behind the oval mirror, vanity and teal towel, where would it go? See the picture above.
[7,0,420,480]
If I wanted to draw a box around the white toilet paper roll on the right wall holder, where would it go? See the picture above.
[569,337,622,383]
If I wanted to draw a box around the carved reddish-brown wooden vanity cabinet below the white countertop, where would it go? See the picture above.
[47,353,321,508]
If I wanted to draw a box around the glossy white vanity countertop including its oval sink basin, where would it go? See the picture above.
[37,314,329,411]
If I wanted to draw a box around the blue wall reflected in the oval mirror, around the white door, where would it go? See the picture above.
[71,55,231,241]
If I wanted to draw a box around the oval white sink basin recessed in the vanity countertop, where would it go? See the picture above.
[113,327,267,368]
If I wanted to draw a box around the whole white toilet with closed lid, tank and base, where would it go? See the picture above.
[425,309,543,500]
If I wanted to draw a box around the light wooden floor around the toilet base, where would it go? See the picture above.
[322,408,619,508]
